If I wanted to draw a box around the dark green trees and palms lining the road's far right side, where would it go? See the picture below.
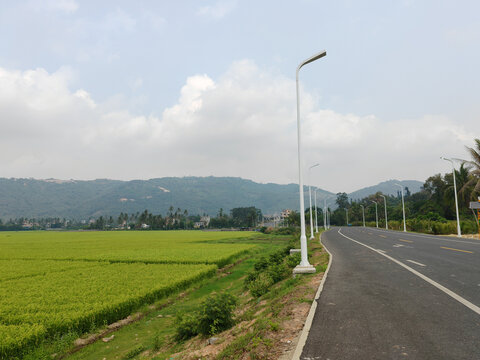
[331,139,480,234]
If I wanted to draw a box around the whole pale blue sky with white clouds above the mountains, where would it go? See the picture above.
[0,0,480,192]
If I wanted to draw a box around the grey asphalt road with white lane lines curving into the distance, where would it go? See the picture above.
[301,227,480,360]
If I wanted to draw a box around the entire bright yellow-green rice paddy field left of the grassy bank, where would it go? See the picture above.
[0,231,254,359]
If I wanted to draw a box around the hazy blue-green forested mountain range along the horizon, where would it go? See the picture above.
[0,176,422,220]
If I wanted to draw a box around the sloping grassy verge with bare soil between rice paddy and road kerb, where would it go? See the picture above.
[20,231,328,360]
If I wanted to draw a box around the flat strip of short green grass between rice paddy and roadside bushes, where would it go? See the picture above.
[62,236,289,360]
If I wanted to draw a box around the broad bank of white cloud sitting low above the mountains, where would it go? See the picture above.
[0,60,479,191]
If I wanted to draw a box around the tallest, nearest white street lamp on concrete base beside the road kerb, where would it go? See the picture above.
[293,51,327,273]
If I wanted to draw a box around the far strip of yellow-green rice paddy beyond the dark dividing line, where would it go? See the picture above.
[0,231,252,267]
